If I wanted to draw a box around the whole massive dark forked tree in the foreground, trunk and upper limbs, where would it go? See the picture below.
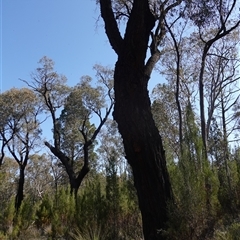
[99,0,181,240]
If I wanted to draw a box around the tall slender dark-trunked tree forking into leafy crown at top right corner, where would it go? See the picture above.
[186,0,240,159]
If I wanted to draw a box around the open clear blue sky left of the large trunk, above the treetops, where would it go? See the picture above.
[1,0,116,92]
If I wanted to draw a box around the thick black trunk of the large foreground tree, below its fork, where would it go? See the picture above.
[114,56,171,240]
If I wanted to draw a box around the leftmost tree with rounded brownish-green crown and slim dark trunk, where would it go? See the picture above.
[0,88,41,211]
